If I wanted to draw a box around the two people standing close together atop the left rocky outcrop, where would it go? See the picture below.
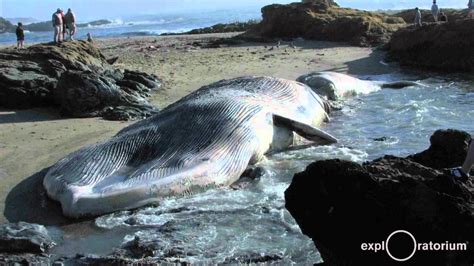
[52,8,76,44]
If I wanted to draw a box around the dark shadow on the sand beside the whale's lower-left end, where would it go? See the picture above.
[4,167,78,225]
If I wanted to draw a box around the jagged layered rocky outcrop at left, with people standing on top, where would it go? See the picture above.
[0,41,161,120]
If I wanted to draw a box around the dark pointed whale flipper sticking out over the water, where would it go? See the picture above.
[273,114,337,143]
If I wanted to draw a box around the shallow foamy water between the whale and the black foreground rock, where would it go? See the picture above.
[53,74,474,265]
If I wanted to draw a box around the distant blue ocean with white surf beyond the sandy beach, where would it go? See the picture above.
[0,8,261,44]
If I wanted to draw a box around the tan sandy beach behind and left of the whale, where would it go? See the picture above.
[0,33,396,224]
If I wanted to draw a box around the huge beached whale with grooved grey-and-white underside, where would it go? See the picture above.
[43,73,414,217]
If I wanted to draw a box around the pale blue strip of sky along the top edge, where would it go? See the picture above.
[0,0,468,20]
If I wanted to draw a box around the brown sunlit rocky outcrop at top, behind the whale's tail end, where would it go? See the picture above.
[242,0,405,46]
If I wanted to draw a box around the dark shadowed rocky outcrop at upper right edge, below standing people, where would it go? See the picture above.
[386,19,474,72]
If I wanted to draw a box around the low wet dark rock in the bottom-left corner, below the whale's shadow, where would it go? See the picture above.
[0,222,55,254]
